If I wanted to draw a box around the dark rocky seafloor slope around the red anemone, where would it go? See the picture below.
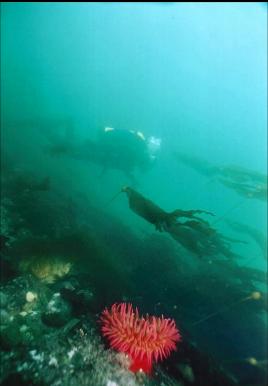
[0,164,267,386]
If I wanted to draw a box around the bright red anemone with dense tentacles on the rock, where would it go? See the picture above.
[100,303,181,374]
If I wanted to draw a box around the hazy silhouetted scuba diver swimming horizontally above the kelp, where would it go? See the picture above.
[49,127,161,182]
